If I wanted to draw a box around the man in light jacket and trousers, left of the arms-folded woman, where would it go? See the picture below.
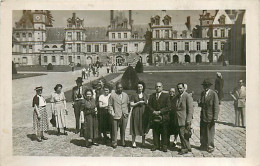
[108,82,130,149]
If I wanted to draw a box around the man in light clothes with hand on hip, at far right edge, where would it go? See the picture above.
[230,79,246,127]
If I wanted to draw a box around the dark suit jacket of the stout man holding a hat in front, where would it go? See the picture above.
[148,92,170,123]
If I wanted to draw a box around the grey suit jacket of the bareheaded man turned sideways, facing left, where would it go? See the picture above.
[175,92,194,126]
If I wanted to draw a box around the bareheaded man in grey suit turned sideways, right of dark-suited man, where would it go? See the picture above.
[175,83,193,155]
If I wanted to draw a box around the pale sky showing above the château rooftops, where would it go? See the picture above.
[13,10,215,27]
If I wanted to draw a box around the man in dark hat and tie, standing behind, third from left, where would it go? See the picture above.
[72,77,84,134]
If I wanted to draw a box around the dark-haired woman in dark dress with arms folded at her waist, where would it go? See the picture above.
[130,81,149,148]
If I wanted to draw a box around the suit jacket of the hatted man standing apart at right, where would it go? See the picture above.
[199,89,219,122]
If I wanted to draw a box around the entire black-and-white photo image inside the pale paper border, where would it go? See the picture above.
[12,9,247,158]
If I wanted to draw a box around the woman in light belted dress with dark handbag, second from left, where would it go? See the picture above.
[51,84,68,135]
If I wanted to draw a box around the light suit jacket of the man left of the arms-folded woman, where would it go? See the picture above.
[108,92,130,119]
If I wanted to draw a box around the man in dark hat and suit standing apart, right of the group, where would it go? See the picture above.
[198,79,219,153]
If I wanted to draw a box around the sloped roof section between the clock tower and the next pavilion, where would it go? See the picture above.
[46,27,65,43]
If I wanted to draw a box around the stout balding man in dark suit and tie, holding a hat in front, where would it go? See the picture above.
[148,82,169,152]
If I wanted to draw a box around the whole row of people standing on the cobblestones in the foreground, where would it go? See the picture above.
[33,72,245,155]
